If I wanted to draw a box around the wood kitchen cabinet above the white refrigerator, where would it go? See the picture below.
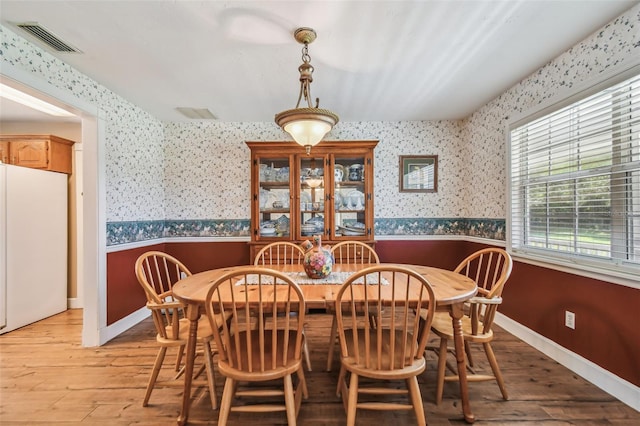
[0,135,74,174]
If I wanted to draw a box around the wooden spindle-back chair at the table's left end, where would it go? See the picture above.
[135,251,217,409]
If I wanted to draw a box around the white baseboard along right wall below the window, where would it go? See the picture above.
[495,312,640,411]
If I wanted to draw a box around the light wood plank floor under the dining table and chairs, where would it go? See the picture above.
[0,310,640,426]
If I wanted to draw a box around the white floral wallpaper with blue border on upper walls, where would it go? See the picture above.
[0,5,640,245]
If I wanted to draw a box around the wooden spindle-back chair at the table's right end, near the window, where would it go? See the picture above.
[430,248,513,404]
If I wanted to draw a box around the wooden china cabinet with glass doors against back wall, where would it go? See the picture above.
[247,141,378,258]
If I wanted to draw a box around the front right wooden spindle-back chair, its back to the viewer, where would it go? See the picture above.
[335,265,435,425]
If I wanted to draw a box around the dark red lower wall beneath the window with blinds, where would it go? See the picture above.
[498,262,640,386]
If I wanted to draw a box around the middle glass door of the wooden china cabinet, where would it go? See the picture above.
[298,153,328,239]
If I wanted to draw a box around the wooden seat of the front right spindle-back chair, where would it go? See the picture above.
[342,330,426,378]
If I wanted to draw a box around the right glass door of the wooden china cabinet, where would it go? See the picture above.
[333,154,373,239]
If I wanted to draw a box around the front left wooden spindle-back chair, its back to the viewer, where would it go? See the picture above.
[205,266,307,425]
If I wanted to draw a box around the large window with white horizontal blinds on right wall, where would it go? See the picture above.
[510,71,640,268]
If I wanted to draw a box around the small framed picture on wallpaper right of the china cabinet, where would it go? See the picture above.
[399,155,438,192]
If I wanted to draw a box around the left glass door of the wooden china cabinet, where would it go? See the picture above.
[257,156,291,239]
